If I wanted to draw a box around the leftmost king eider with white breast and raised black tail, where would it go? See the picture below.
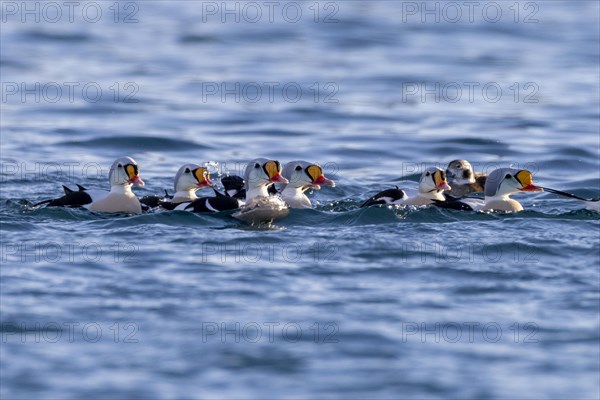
[36,157,144,214]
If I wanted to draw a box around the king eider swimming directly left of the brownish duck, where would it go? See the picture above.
[361,167,450,207]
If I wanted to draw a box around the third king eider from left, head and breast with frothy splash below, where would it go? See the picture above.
[233,158,289,224]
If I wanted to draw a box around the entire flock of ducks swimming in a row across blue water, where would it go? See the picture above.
[35,157,600,223]
